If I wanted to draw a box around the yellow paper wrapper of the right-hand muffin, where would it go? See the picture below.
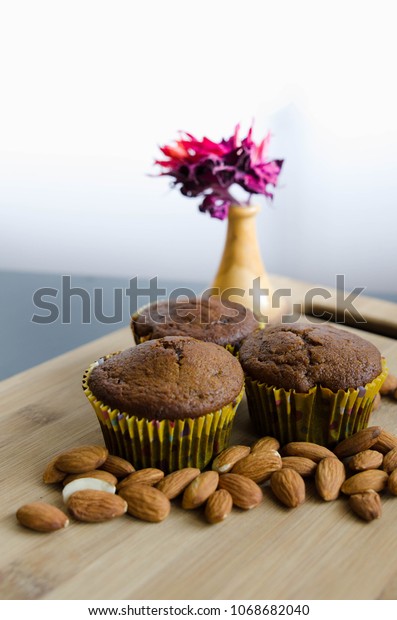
[245,359,388,447]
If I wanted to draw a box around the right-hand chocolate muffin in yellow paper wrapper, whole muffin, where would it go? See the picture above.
[239,323,387,446]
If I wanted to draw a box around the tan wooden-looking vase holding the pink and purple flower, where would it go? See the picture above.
[212,205,280,323]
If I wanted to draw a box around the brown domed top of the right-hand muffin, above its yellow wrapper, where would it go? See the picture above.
[239,323,382,392]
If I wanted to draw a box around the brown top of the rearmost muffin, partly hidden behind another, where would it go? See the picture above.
[131,297,258,346]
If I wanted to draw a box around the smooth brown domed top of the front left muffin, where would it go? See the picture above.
[87,336,244,420]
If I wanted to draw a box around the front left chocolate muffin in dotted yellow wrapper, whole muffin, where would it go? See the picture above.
[83,336,244,471]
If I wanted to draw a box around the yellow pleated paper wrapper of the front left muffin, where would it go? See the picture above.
[83,353,244,472]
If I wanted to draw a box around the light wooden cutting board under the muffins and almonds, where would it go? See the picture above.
[0,322,397,600]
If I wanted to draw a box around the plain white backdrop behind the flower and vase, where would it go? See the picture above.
[0,0,397,294]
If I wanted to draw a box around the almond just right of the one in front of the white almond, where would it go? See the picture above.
[120,483,171,523]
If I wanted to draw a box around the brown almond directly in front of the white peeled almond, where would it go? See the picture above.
[67,489,127,523]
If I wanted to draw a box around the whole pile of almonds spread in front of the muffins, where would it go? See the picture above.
[17,426,397,532]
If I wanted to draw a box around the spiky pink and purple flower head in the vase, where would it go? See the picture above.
[155,125,283,220]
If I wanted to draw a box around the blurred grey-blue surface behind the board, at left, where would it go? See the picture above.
[0,271,205,380]
